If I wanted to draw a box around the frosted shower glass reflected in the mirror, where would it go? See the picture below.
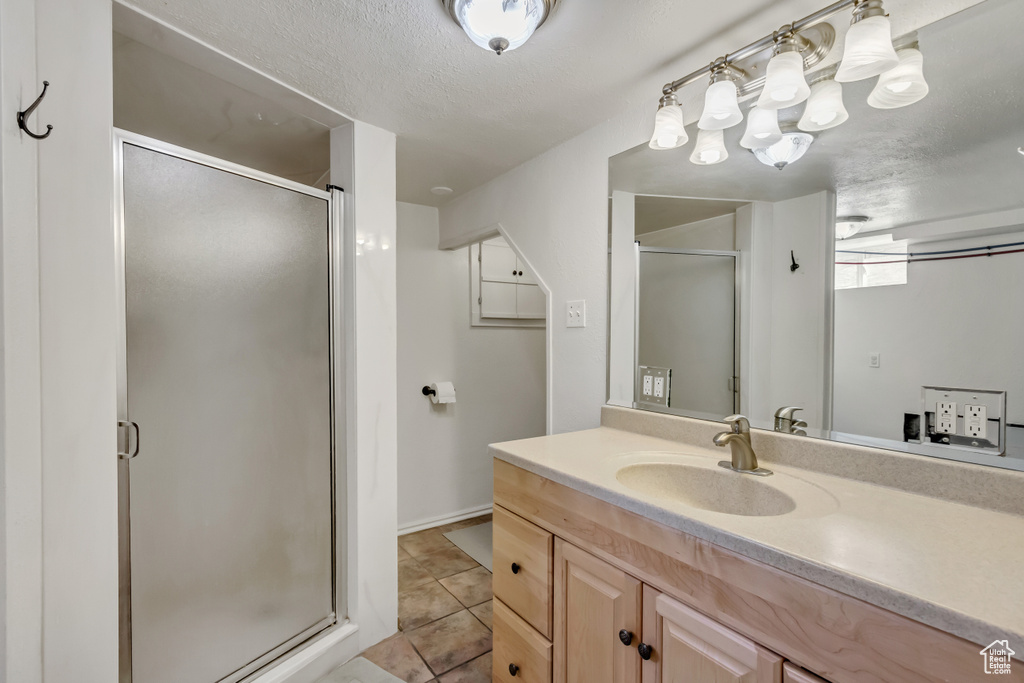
[637,250,737,417]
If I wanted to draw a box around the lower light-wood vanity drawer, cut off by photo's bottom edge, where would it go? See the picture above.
[493,599,551,683]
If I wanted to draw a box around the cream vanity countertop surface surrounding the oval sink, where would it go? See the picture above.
[490,427,1024,652]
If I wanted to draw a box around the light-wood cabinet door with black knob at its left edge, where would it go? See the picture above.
[643,586,782,683]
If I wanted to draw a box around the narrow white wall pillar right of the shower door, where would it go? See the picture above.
[331,121,398,649]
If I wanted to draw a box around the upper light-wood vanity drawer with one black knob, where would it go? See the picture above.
[494,506,554,640]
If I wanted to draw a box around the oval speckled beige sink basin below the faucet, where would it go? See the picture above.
[615,463,797,517]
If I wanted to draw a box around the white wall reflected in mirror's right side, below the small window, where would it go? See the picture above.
[835,232,1024,440]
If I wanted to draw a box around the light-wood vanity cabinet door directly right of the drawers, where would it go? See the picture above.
[554,539,642,683]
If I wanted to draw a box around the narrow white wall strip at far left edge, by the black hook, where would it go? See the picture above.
[0,0,43,681]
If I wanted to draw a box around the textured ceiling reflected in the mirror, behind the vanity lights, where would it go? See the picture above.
[610,0,1024,235]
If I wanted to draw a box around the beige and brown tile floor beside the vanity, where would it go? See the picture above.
[362,515,494,683]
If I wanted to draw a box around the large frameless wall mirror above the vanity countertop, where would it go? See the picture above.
[609,0,1024,470]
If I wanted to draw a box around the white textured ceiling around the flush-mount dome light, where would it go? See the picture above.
[117,0,856,205]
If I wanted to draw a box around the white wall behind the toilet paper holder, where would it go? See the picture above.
[397,203,546,528]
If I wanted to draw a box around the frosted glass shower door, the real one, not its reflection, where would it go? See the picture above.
[122,138,336,683]
